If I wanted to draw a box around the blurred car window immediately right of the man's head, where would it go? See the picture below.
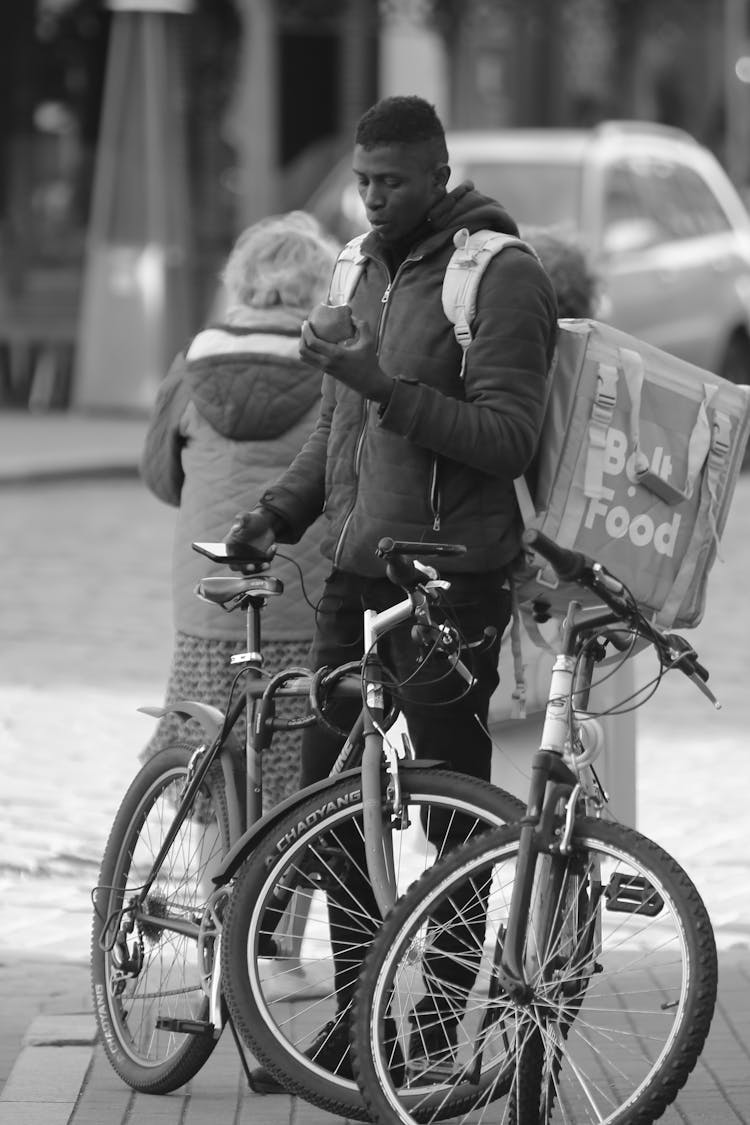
[457,159,581,231]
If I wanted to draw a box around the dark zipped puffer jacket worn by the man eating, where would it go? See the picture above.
[261,191,557,576]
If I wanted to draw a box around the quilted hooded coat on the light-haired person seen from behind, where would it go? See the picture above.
[141,309,328,640]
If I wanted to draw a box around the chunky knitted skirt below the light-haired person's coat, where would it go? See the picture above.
[141,632,309,811]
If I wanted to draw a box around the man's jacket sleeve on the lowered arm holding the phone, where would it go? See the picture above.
[261,375,335,543]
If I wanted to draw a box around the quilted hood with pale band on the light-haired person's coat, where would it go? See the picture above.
[186,325,320,441]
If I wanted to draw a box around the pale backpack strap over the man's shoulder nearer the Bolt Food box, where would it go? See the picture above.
[442,227,539,378]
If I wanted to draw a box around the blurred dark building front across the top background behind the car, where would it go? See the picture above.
[0,0,750,410]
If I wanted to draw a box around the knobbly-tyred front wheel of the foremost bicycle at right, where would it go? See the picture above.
[353,818,717,1125]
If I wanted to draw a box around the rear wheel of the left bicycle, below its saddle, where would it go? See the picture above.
[91,743,229,1094]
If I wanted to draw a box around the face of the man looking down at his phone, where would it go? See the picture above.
[352,144,449,242]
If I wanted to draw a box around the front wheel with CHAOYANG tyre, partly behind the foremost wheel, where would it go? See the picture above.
[222,770,523,1119]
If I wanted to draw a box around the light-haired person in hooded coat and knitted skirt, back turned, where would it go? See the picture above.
[141,212,338,808]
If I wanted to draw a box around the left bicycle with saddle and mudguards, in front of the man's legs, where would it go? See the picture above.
[92,540,523,1117]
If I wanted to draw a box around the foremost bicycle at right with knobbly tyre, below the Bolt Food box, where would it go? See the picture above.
[352,532,719,1125]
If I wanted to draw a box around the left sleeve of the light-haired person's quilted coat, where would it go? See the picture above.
[139,352,190,507]
